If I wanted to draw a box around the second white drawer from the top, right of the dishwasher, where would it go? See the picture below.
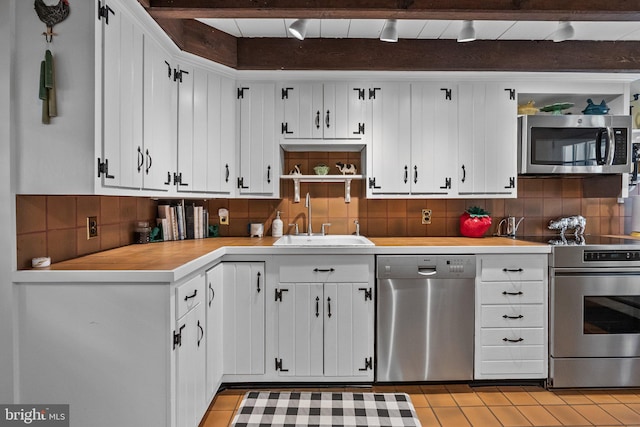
[479,282,545,305]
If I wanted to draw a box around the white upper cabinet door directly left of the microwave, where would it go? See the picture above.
[456,83,518,197]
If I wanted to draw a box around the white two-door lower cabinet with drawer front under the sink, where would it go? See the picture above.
[270,255,375,381]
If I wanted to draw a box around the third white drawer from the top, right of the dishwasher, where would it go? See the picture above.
[480,304,546,328]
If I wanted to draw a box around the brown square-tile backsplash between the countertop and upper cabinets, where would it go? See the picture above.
[16,158,631,269]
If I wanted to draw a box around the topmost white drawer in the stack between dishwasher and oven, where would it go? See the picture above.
[480,255,547,282]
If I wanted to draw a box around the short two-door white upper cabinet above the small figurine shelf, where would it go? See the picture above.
[278,82,368,140]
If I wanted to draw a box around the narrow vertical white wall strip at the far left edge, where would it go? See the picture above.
[0,0,16,403]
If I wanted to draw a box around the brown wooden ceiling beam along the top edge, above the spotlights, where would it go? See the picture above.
[141,0,640,21]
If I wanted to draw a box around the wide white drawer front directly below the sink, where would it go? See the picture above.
[279,255,373,283]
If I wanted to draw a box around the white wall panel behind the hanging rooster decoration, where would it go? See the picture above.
[15,0,96,194]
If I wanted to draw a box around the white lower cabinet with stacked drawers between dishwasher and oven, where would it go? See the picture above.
[474,254,548,379]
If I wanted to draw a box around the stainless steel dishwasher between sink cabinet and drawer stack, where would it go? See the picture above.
[376,255,476,381]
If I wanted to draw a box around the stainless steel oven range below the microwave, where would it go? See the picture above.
[548,237,640,388]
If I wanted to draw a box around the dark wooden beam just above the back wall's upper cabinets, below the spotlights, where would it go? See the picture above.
[237,38,640,72]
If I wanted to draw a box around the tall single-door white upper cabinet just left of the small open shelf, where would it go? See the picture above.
[236,83,280,197]
